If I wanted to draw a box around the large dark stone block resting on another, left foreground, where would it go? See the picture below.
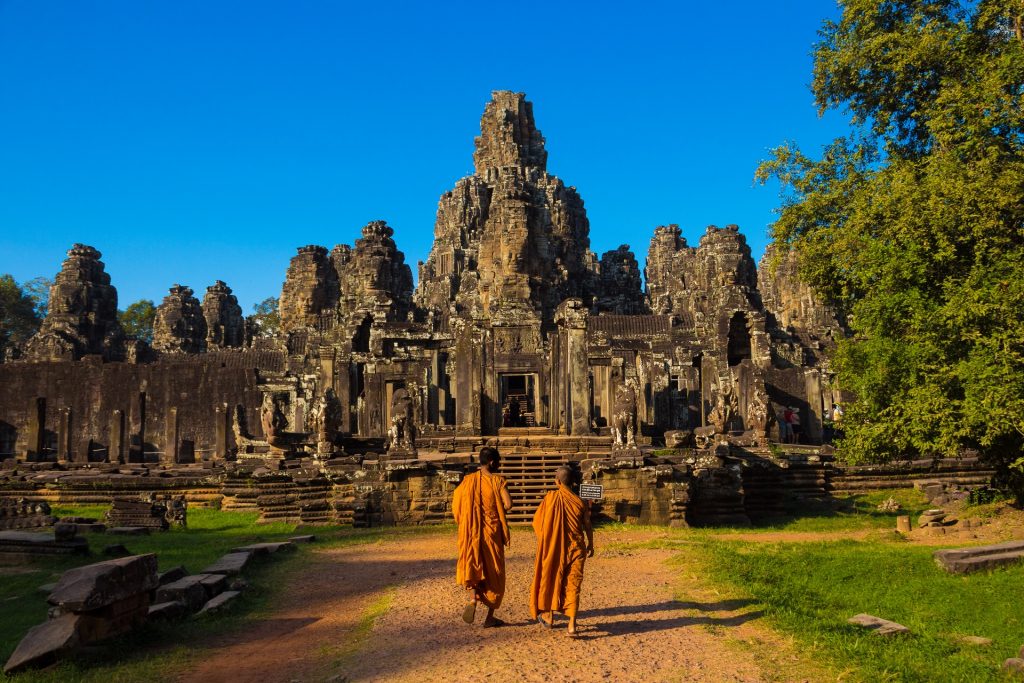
[47,553,159,612]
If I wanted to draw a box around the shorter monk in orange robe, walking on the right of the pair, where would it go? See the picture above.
[529,467,594,636]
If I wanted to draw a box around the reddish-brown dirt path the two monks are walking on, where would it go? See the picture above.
[181,529,823,683]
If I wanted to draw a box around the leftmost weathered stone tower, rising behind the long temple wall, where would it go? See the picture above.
[26,244,125,360]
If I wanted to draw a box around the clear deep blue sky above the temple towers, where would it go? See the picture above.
[0,0,845,313]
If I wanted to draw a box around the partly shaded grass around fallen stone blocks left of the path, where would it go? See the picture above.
[0,507,435,683]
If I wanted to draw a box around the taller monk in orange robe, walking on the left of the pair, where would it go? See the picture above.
[452,446,512,628]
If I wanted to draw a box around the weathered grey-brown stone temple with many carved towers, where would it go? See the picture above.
[0,91,864,524]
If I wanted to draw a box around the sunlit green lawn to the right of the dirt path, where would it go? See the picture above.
[687,537,1024,682]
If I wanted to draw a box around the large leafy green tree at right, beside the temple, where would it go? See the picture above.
[757,0,1024,500]
